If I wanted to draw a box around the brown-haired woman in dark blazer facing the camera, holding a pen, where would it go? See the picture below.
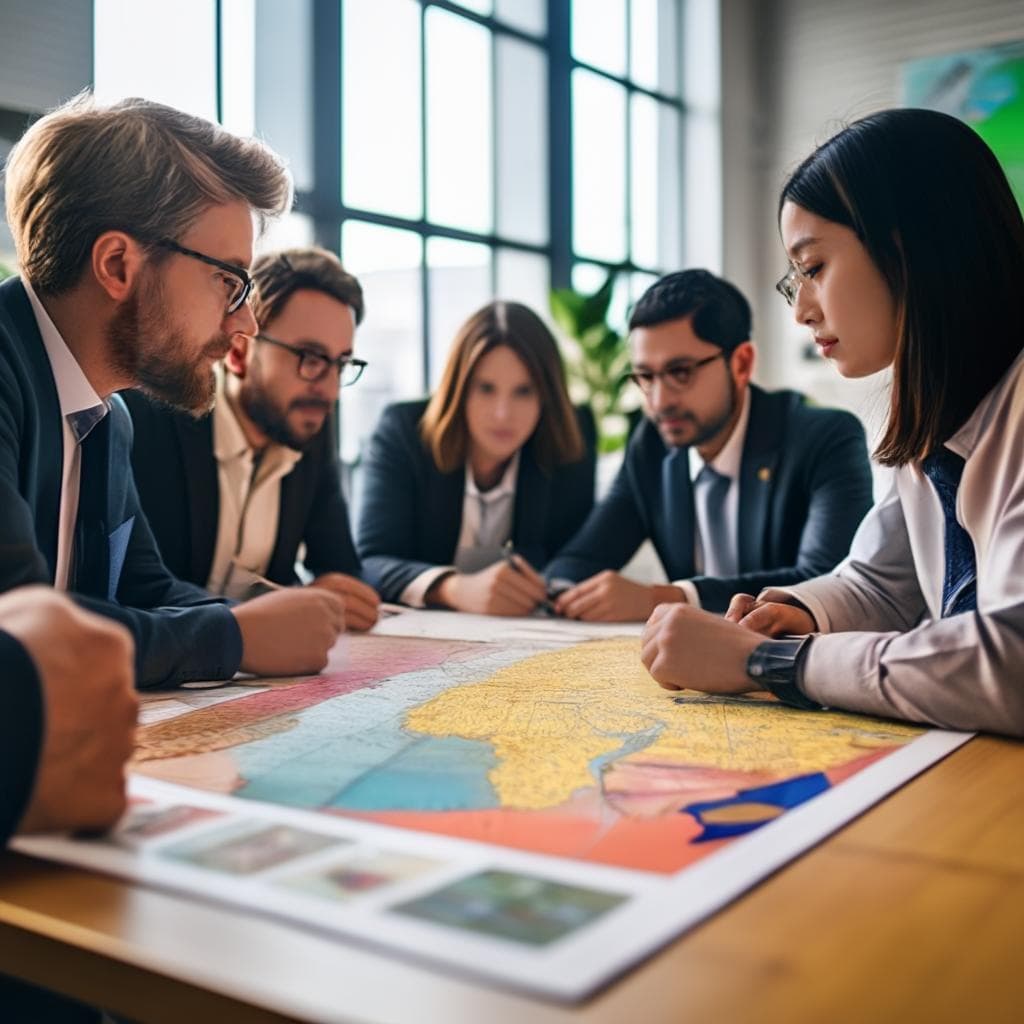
[356,302,595,615]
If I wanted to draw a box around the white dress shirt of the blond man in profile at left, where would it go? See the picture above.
[22,278,108,590]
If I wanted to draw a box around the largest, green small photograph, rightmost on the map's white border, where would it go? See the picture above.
[392,871,629,946]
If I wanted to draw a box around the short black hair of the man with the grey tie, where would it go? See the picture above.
[630,270,751,352]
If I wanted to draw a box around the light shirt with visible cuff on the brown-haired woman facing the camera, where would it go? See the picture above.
[400,452,519,608]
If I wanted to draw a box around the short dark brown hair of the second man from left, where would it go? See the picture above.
[252,247,364,328]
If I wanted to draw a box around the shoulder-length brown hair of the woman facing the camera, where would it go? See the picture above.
[420,302,584,473]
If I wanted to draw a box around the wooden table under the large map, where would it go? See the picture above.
[0,737,1024,1024]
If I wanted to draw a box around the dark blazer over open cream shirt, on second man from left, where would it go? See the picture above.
[122,391,361,587]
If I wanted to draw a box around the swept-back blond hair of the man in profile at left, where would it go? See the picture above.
[6,92,292,295]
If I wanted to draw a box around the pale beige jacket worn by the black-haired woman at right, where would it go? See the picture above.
[786,354,1024,736]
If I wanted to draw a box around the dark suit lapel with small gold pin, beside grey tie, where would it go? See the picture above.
[738,386,784,572]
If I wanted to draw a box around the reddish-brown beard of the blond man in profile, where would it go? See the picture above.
[106,278,230,416]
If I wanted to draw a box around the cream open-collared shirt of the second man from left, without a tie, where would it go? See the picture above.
[206,368,302,600]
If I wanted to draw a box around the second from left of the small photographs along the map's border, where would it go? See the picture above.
[160,821,339,874]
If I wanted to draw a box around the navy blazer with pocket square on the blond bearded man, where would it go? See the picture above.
[0,279,242,686]
